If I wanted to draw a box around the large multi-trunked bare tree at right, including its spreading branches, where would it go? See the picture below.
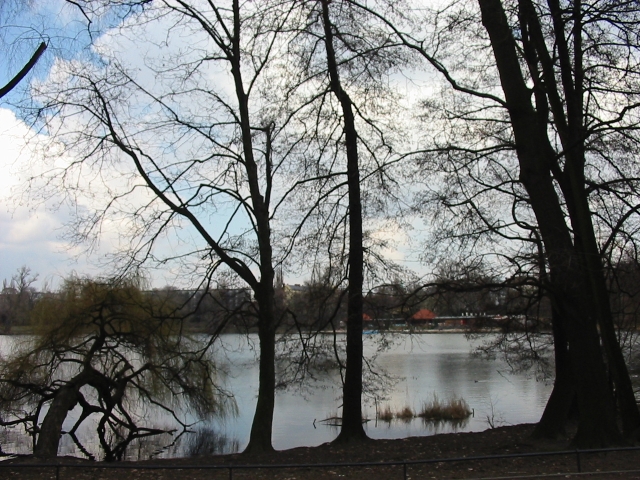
[362,0,639,446]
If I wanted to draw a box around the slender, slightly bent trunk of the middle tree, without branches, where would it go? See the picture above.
[321,0,368,443]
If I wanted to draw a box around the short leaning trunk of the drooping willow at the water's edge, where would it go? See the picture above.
[33,384,78,458]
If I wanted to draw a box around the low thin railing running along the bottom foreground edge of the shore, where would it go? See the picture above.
[0,447,640,480]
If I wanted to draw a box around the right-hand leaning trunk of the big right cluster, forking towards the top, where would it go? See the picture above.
[519,0,640,434]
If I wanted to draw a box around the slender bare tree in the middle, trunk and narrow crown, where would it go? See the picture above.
[284,0,404,442]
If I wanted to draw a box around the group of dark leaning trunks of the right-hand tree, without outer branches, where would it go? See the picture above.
[480,1,640,444]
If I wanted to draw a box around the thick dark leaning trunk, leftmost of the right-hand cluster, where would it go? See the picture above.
[479,0,620,447]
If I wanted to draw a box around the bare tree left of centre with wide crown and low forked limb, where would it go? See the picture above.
[28,0,356,452]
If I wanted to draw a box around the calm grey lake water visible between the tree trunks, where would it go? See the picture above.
[0,333,551,458]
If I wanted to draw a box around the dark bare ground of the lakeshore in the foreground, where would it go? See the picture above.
[0,425,640,480]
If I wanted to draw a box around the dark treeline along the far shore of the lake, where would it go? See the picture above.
[7,261,640,335]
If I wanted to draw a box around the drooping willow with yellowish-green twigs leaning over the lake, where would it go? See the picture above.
[0,279,232,460]
